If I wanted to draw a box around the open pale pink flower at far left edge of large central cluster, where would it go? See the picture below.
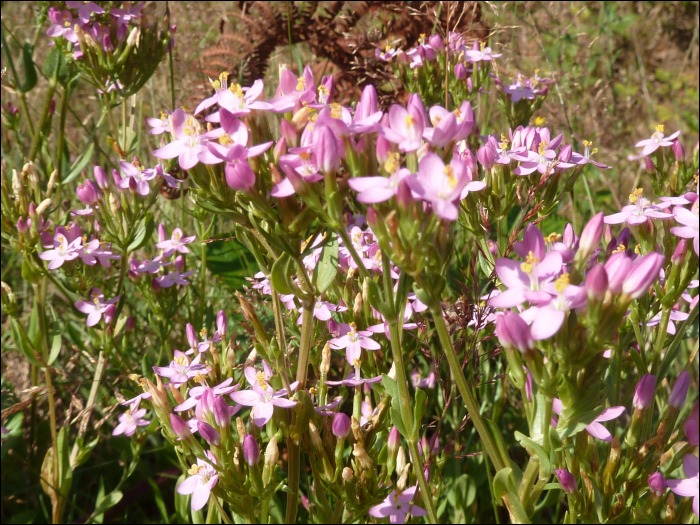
[153,108,224,170]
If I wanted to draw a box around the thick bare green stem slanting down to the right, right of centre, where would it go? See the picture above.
[430,304,506,472]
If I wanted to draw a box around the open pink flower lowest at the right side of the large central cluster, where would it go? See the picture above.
[406,152,469,221]
